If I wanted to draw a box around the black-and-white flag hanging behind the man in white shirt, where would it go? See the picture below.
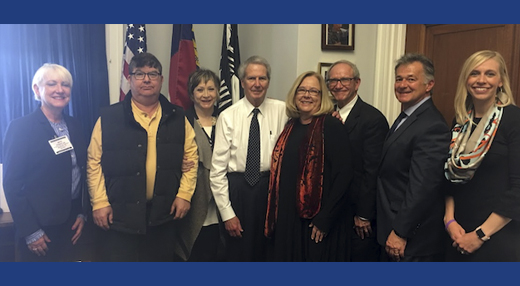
[218,24,244,113]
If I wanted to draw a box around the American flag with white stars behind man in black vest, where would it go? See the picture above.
[119,24,146,101]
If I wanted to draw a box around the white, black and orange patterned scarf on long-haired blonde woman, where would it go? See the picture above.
[444,101,503,184]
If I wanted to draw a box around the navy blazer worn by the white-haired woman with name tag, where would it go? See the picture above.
[3,108,88,238]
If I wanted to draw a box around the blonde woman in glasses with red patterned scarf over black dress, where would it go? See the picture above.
[265,71,353,261]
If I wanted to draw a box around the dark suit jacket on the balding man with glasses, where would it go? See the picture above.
[345,97,388,220]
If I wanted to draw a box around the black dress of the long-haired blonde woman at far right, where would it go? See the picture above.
[446,106,520,261]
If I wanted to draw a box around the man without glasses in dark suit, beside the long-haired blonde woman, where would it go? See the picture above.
[377,54,450,261]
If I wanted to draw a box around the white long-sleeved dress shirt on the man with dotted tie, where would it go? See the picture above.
[209,97,288,221]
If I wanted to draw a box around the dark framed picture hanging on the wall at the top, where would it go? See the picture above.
[321,24,355,51]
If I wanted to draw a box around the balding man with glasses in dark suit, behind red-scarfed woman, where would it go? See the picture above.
[326,60,388,261]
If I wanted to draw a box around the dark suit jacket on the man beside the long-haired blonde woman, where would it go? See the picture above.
[377,98,451,256]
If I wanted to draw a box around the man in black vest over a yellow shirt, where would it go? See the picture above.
[87,53,198,261]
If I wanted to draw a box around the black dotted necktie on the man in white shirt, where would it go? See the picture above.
[244,108,260,186]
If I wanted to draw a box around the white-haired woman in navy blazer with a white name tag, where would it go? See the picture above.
[3,64,87,262]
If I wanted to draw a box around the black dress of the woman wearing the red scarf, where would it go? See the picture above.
[268,116,353,261]
